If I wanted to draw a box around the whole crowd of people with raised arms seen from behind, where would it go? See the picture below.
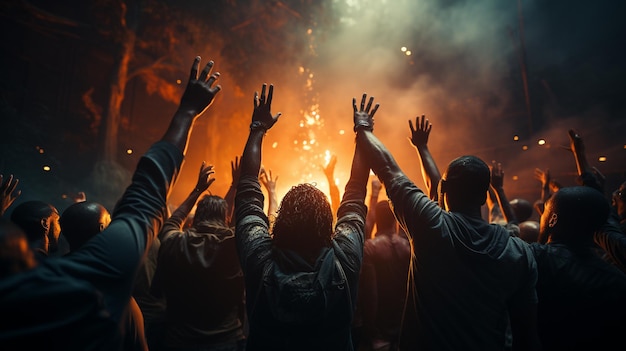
[0,57,626,351]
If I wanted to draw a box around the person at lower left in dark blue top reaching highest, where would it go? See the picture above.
[0,57,220,351]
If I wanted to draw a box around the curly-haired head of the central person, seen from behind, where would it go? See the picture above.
[272,184,333,261]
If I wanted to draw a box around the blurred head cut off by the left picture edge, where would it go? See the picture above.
[0,219,37,279]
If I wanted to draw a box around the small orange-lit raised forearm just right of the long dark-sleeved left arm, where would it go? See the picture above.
[158,161,215,242]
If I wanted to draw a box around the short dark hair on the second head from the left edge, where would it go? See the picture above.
[11,200,58,242]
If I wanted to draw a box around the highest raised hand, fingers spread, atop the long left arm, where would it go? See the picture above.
[178,56,222,117]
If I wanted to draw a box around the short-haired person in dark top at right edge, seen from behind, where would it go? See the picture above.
[531,186,626,350]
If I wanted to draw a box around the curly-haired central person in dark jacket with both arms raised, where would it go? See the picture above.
[235,88,370,351]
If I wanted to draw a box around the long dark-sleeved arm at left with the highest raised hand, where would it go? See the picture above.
[72,57,220,321]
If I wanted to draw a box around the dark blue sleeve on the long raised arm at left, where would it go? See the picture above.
[67,141,184,318]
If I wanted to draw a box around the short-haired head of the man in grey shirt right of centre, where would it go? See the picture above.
[439,156,491,212]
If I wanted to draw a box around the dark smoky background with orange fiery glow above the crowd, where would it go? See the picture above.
[0,0,626,217]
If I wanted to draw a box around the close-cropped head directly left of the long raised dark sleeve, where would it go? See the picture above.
[59,201,111,251]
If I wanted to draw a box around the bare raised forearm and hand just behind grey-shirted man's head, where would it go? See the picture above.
[409,115,441,201]
